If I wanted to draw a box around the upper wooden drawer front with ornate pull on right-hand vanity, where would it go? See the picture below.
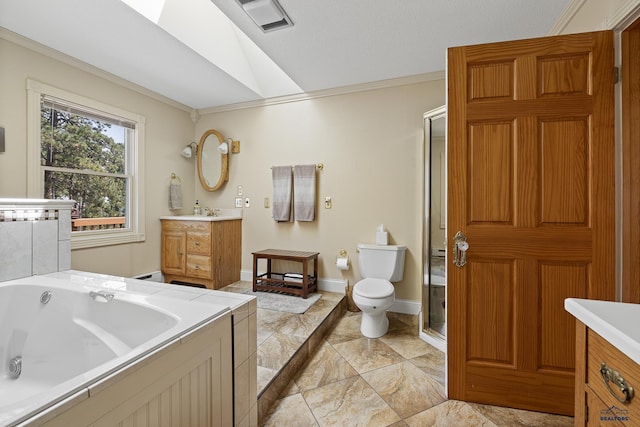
[586,329,640,425]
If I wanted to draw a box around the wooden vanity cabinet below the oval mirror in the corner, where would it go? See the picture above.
[162,219,242,289]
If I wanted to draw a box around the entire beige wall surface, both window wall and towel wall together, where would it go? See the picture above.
[0,30,445,301]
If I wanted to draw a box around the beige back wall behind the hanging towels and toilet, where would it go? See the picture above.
[196,80,445,301]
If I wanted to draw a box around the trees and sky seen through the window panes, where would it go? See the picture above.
[41,102,131,229]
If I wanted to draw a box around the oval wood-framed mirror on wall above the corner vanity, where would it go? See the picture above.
[198,129,229,191]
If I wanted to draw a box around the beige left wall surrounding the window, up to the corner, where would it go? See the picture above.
[0,33,194,276]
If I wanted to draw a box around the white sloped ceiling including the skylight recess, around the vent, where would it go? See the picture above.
[0,0,570,109]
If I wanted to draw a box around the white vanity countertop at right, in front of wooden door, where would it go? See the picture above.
[564,298,640,364]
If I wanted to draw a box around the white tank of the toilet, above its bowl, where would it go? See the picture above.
[358,243,407,282]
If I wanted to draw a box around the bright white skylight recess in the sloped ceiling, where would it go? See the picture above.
[121,0,302,98]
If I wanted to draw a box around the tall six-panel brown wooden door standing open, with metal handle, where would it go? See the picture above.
[447,32,615,414]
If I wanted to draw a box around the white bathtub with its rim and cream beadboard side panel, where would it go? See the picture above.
[0,273,233,427]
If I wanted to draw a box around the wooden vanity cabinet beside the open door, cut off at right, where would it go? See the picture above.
[574,321,640,426]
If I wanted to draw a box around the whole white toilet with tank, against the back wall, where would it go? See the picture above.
[353,243,407,338]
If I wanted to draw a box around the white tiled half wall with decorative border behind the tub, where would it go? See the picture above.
[0,198,74,281]
